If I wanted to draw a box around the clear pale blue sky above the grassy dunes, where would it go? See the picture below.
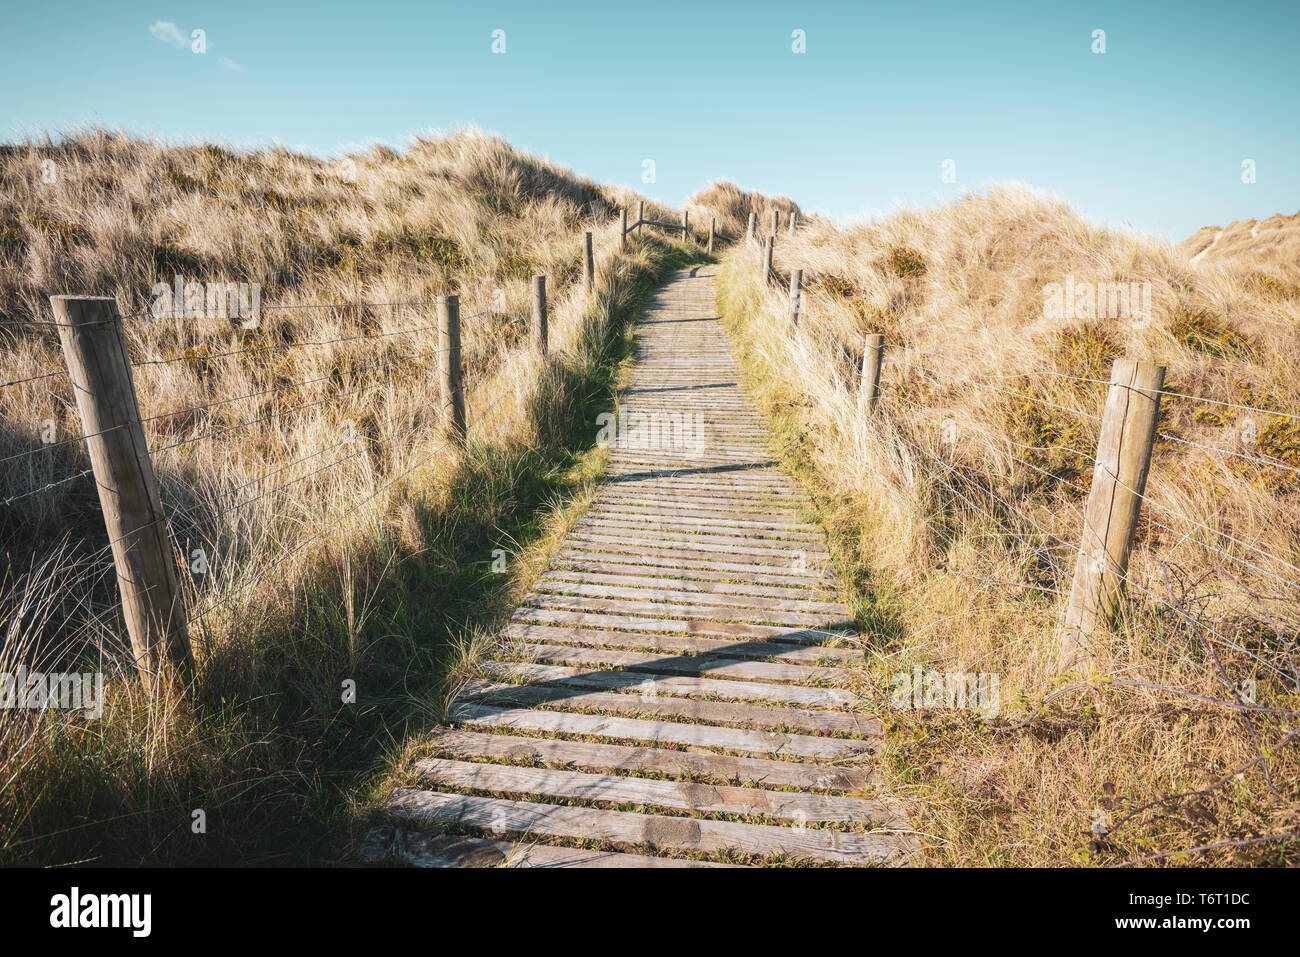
[0,0,1300,239]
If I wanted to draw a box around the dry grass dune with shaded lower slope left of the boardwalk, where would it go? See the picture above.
[0,130,702,863]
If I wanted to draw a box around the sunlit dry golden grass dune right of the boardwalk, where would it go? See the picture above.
[723,189,1300,865]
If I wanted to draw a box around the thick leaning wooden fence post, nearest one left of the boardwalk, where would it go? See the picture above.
[49,295,194,693]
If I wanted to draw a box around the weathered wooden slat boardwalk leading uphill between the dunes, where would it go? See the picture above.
[364,268,915,867]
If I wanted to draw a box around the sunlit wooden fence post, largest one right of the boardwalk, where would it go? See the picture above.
[1061,359,1165,670]
